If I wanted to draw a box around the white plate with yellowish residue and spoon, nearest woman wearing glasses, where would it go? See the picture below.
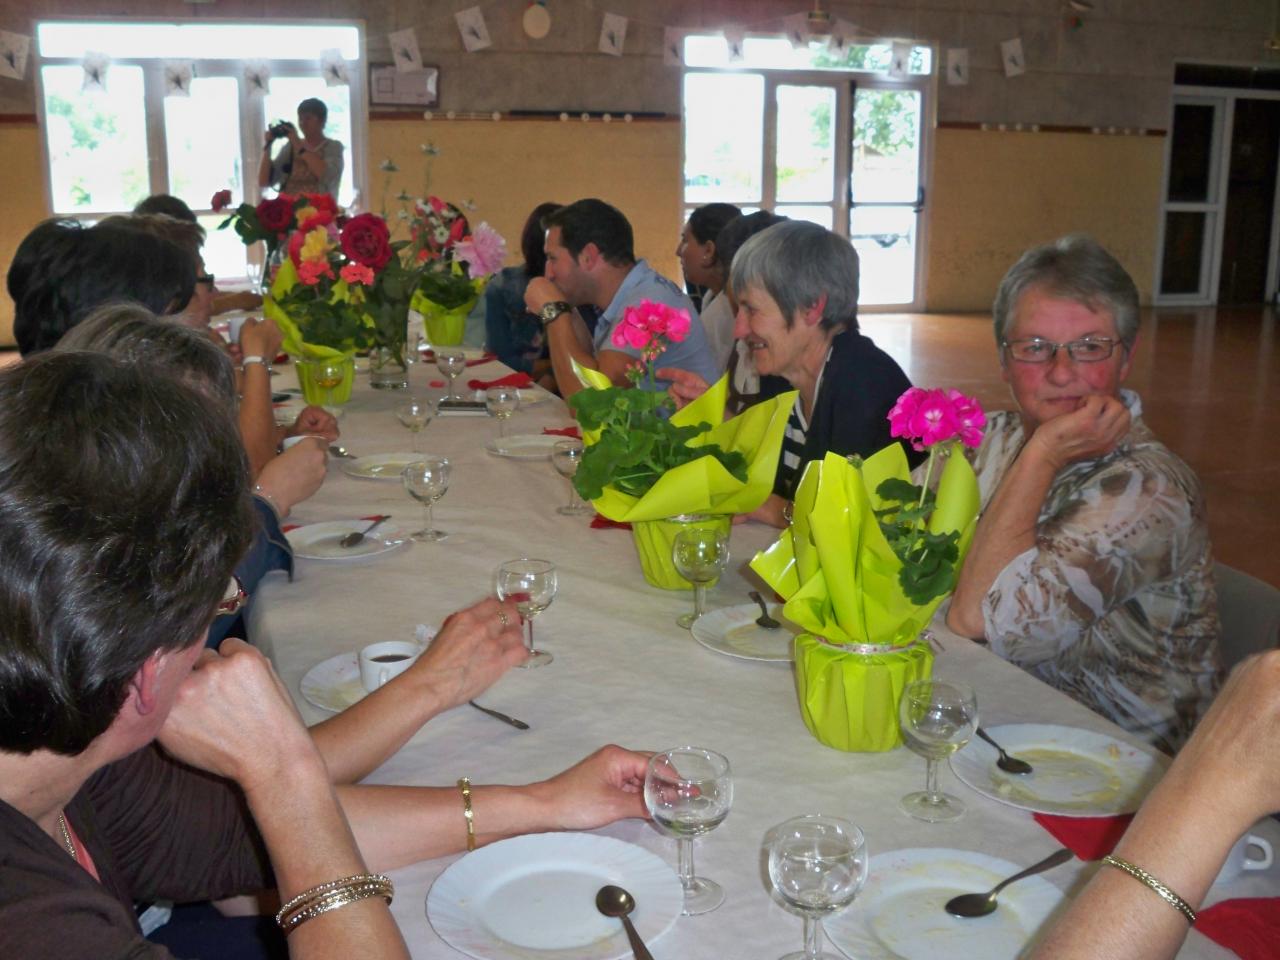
[951,723,1169,817]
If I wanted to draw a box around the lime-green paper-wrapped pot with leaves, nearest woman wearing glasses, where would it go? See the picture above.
[751,388,982,751]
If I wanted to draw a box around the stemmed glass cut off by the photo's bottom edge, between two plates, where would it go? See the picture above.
[765,814,867,960]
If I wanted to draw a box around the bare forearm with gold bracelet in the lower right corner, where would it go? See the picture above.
[1033,650,1280,960]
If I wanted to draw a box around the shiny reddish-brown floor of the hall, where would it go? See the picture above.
[0,308,1280,586]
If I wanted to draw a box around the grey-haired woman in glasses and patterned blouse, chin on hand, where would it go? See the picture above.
[947,237,1220,749]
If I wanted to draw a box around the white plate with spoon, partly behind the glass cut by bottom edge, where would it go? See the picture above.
[823,849,1065,960]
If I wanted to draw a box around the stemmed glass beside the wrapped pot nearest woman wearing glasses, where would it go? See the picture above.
[897,680,978,823]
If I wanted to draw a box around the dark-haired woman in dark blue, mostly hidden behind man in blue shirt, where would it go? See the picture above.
[484,202,561,390]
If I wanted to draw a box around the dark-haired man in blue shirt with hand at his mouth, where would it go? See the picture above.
[525,200,723,398]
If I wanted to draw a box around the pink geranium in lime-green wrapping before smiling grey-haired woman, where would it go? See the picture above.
[568,301,795,590]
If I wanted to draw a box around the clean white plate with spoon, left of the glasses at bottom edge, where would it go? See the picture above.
[426,833,684,960]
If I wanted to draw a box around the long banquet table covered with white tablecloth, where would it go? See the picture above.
[251,362,1280,960]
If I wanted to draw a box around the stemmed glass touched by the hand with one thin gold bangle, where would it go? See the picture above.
[644,746,733,916]
